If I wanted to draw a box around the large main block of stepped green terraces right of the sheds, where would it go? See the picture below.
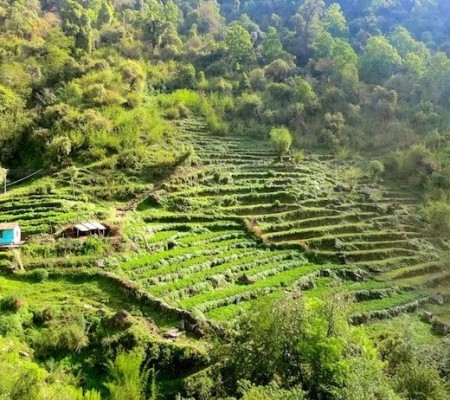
[121,120,445,322]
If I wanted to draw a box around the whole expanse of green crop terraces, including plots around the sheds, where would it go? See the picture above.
[0,120,450,323]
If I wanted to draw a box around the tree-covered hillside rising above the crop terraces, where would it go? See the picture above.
[0,0,450,175]
